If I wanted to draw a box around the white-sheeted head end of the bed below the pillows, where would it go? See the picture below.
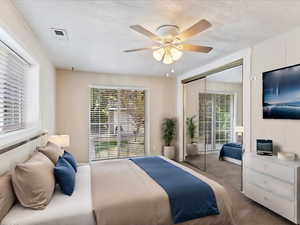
[1,165,96,225]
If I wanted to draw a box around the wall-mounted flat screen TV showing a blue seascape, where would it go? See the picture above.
[263,64,300,119]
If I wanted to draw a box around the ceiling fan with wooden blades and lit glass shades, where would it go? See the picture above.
[124,19,213,64]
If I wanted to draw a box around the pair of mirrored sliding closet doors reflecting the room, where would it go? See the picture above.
[184,65,243,190]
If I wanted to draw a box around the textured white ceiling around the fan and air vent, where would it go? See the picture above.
[13,0,300,75]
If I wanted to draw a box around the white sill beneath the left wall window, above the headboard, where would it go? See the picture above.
[0,128,45,149]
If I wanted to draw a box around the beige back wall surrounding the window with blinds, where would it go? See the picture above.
[56,70,176,162]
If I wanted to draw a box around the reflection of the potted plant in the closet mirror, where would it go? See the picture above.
[186,115,198,155]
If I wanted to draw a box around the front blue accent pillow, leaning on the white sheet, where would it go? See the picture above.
[54,156,75,195]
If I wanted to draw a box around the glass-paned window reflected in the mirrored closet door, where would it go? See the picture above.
[199,93,234,151]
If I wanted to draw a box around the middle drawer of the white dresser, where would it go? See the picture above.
[245,168,295,201]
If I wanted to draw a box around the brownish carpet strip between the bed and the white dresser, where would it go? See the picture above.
[183,163,293,225]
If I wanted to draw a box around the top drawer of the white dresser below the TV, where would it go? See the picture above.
[245,156,294,184]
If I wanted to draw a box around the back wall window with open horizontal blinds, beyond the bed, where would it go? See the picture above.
[89,88,145,160]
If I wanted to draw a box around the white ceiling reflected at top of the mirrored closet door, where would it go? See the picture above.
[207,66,243,84]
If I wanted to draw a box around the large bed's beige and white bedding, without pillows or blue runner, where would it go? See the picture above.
[0,133,235,225]
